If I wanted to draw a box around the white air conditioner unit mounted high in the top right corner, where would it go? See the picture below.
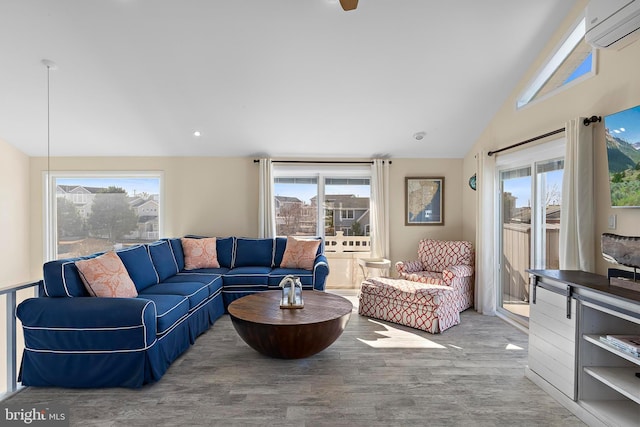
[584,0,640,49]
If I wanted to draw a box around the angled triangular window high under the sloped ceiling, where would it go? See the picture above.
[516,17,596,109]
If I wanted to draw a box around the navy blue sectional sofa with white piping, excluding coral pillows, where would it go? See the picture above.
[16,237,329,388]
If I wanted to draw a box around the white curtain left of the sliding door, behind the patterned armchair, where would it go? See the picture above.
[475,151,498,316]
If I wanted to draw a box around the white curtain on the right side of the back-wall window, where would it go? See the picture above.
[371,159,389,258]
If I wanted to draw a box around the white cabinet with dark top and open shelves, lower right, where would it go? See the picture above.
[526,270,640,427]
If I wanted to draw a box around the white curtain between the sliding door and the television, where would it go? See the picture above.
[560,117,595,272]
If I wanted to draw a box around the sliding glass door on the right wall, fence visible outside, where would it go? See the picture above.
[497,140,564,324]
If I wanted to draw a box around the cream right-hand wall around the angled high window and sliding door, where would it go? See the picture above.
[462,0,640,274]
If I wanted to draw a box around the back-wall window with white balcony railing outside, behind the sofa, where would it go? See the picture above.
[273,162,371,288]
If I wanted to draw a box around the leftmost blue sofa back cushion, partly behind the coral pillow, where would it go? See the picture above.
[42,254,100,297]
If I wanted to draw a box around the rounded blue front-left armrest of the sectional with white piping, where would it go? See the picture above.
[16,297,156,353]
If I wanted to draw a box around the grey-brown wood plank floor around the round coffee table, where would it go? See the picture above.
[3,291,583,427]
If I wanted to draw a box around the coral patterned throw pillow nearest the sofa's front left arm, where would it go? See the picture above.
[75,251,138,298]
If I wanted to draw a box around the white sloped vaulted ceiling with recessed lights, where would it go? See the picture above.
[0,0,576,158]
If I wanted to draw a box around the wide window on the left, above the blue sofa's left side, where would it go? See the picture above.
[45,172,161,259]
